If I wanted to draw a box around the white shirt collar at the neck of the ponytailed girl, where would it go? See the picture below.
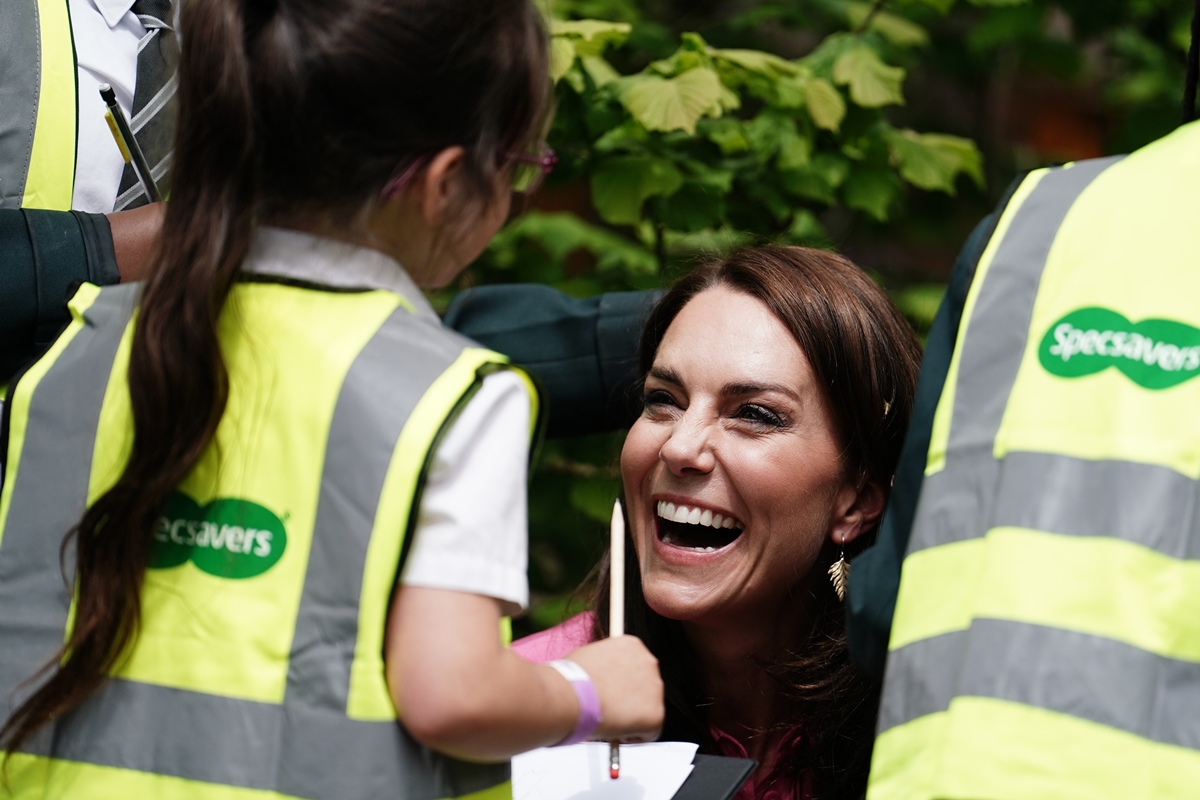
[241,227,442,325]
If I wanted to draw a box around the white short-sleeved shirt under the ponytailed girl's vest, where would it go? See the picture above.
[242,228,530,614]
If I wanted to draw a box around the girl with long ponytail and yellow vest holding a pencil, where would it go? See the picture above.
[0,0,662,800]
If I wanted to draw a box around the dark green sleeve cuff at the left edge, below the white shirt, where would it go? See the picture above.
[0,209,121,384]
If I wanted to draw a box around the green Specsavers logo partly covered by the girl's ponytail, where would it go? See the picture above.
[150,492,288,578]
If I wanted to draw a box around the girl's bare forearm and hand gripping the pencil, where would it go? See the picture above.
[384,585,662,760]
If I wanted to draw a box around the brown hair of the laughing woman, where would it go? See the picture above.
[594,247,920,800]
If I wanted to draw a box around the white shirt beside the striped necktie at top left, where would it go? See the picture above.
[69,0,148,213]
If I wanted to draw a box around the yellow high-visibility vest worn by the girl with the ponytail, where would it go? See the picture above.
[0,278,538,800]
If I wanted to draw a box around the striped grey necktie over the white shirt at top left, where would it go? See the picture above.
[114,0,179,211]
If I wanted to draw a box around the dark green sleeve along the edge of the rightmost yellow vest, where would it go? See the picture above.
[846,208,1012,680]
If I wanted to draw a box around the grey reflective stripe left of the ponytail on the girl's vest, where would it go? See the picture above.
[0,285,137,718]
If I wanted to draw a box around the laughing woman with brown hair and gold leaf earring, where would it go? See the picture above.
[514,247,920,800]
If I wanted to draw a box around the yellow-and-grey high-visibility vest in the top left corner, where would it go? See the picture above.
[0,0,78,211]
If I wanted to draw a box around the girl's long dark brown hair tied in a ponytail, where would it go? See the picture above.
[0,0,548,754]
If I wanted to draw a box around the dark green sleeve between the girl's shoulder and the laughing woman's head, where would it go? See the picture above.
[445,283,658,437]
